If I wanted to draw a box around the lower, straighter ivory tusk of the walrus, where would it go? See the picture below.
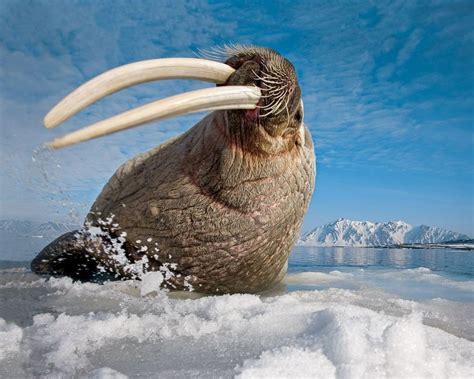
[48,86,261,149]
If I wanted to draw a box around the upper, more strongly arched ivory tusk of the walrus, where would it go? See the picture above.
[44,58,235,128]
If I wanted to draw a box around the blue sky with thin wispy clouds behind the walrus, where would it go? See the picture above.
[0,0,474,236]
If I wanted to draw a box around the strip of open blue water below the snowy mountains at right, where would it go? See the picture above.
[289,246,474,276]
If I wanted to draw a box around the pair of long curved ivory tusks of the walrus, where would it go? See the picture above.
[44,58,261,148]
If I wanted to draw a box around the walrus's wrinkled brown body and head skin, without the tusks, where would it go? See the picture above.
[32,48,315,293]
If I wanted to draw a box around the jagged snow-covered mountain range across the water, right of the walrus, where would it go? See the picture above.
[298,218,469,246]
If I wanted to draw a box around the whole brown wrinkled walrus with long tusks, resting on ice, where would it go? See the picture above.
[31,46,315,294]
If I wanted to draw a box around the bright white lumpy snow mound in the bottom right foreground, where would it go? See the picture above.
[241,307,472,378]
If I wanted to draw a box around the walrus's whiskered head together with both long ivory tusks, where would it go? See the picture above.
[44,46,304,154]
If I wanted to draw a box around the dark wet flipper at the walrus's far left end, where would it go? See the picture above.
[31,230,104,281]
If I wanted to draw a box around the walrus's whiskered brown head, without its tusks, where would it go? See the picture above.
[220,47,304,154]
